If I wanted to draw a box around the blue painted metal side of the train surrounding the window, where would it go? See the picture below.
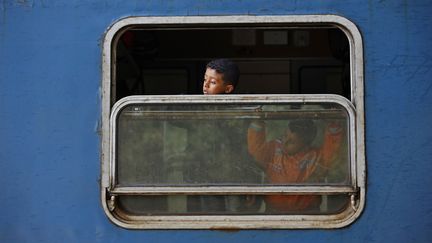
[0,0,432,242]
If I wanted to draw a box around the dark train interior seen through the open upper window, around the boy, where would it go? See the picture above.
[112,26,350,102]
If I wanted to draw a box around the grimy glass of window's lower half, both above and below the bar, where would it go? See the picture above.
[116,100,351,215]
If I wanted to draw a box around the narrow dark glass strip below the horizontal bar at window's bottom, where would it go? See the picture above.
[119,194,350,216]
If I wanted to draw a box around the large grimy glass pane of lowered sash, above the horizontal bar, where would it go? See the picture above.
[116,101,350,186]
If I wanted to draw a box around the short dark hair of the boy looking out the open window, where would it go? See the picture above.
[206,59,240,87]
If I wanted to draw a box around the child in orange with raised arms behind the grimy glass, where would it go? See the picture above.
[248,120,342,213]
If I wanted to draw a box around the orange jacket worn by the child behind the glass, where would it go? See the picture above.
[248,123,342,212]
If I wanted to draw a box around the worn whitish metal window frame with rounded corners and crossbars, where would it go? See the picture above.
[101,15,366,229]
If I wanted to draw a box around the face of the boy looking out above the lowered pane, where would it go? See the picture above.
[203,68,234,95]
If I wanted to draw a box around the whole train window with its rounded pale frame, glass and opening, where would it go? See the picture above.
[101,15,365,229]
